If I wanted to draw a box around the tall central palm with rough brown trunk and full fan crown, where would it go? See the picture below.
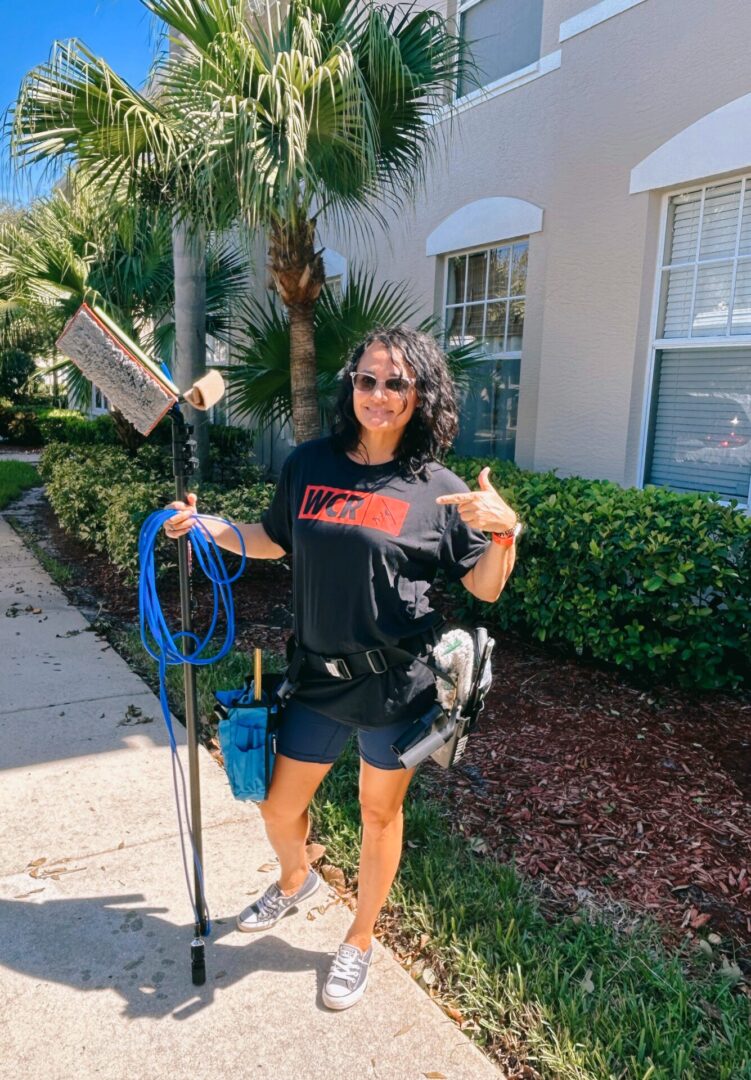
[144,0,471,442]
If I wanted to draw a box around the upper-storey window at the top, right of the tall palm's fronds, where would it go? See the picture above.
[457,0,542,97]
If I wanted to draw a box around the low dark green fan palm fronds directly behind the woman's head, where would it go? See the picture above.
[223,268,486,430]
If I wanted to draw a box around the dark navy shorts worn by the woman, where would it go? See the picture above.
[277,697,423,769]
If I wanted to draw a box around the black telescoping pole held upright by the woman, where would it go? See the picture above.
[170,407,207,986]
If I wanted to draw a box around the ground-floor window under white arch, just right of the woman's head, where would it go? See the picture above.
[444,240,528,459]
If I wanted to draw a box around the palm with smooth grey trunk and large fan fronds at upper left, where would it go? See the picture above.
[5,39,220,467]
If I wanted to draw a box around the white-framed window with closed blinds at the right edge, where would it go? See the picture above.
[646,177,751,502]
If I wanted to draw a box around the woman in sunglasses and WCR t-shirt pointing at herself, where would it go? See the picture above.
[165,325,518,1009]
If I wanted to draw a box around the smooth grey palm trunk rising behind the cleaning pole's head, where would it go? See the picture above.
[172,214,209,478]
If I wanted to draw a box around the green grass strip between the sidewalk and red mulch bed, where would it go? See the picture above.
[120,633,751,1080]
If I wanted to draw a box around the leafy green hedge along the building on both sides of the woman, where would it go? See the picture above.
[41,436,751,690]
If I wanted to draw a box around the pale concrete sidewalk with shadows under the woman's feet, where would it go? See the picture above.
[0,501,501,1080]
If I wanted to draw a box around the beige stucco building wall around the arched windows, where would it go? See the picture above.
[309,0,751,485]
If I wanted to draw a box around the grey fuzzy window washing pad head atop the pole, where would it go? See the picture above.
[57,303,225,435]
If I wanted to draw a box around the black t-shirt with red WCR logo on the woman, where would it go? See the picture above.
[260,435,490,728]
